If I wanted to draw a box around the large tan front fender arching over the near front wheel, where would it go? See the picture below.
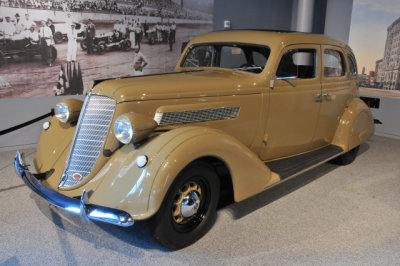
[89,127,279,220]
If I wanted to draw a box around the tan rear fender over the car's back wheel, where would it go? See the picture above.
[332,98,374,152]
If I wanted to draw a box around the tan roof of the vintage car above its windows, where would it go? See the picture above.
[191,30,351,51]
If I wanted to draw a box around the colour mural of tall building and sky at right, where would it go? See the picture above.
[349,0,400,97]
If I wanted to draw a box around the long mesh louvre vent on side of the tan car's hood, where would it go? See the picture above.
[154,106,240,125]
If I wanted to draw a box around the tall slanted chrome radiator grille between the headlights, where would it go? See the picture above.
[59,94,116,188]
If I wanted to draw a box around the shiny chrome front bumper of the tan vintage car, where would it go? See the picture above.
[14,152,134,227]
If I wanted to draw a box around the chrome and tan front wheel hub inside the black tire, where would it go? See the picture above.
[172,181,201,224]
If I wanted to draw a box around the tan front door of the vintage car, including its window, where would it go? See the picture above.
[261,45,321,160]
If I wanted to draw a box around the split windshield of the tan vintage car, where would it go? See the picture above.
[181,44,270,73]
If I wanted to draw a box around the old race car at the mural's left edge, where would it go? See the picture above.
[0,33,57,65]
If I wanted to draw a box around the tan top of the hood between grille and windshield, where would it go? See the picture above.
[92,69,266,103]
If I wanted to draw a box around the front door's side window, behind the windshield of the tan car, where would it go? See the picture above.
[276,49,317,79]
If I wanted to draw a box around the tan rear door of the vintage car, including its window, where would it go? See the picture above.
[315,45,354,145]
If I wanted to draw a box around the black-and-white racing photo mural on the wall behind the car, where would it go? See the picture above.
[0,0,214,98]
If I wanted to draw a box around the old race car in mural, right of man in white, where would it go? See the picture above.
[81,30,131,54]
